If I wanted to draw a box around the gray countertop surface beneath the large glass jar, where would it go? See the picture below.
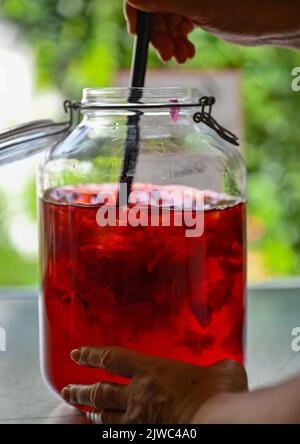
[0,285,300,424]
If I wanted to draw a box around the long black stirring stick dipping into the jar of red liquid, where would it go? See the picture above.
[119,11,152,206]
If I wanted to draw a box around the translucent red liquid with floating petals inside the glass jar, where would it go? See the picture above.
[41,186,245,398]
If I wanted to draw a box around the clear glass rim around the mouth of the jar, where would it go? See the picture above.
[81,86,201,105]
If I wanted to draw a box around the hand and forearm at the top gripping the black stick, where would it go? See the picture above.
[124,0,300,63]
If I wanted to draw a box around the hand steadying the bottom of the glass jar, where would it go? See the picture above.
[62,347,247,424]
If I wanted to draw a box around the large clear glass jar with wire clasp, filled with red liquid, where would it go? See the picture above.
[39,88,246,398]
